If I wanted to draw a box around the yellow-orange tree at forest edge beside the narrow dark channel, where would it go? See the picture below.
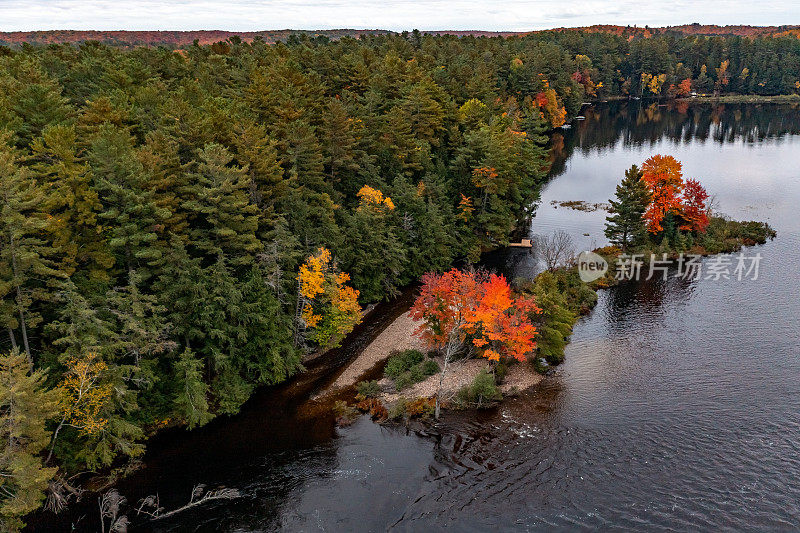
[295,246,360,348]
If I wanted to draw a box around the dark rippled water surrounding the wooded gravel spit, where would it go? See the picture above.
[40,105,800,531]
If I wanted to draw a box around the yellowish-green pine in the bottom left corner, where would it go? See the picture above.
[0,352,57,531]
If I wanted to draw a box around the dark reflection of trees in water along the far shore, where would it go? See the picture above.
[550,101,800,178]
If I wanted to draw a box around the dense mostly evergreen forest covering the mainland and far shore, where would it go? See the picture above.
[0,32,800,528]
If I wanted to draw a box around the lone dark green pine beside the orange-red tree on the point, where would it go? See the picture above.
[605,165,650,251]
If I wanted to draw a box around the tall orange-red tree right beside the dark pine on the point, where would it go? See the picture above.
[642,155,684,233]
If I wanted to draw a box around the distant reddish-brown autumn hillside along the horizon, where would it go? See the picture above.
[0,24,800,48]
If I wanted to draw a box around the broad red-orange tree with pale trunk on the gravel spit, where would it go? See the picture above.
[411,269,541,418]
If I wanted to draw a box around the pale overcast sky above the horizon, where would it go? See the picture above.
[0,0,800,31]
